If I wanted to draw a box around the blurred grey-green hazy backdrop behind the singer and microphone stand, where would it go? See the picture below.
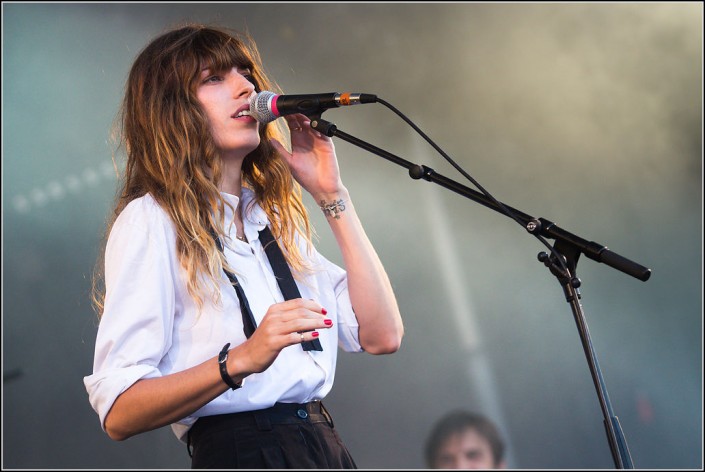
[2,2,703,469]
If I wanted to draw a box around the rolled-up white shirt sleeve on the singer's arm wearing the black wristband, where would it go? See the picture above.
[84,199,176,429]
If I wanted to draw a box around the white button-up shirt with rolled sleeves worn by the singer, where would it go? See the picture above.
[84,189,362,441]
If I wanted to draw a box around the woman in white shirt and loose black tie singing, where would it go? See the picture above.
[84,25,403,468]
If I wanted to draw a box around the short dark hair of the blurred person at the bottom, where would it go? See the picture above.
[425,410,504,468]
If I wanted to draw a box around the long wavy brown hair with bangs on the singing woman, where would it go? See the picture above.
[93,24,312,317]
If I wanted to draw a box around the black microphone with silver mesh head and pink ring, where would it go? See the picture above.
[250,90,377,123]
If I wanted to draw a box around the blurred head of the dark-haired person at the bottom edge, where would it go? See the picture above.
[425,411,506,469]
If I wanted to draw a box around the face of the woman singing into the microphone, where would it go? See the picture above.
[197,67,260,159]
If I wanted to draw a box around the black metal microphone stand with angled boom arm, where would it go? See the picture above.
[309,115,651,469]
